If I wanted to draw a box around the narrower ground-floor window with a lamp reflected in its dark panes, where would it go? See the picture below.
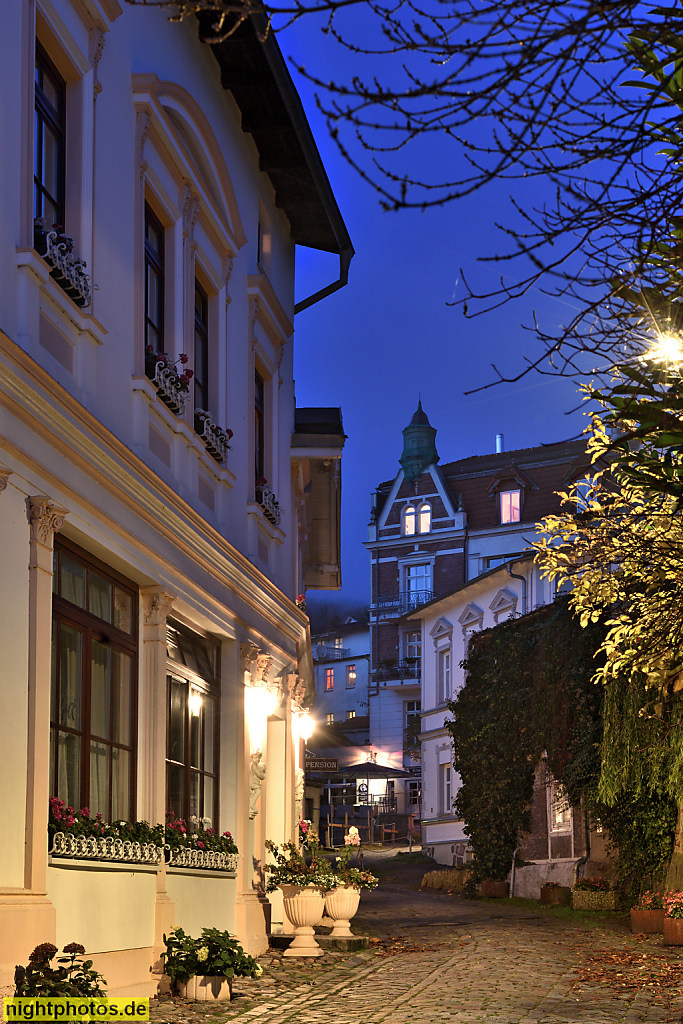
[166,623,219,827]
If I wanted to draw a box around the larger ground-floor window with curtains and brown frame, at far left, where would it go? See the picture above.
[50,542,137,821]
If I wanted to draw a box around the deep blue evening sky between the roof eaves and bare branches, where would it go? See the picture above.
[286,22,586,601]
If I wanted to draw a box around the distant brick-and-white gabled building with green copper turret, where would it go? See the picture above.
[366,402,590,843]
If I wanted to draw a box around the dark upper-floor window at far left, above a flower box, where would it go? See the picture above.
[33,44,67,231]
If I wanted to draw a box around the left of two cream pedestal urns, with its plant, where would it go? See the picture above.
[265,840,335,956]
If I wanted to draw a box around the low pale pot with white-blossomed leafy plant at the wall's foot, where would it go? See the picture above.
[162,928,263,1002]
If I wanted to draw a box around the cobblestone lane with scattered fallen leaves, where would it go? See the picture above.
[152,863,683,1024]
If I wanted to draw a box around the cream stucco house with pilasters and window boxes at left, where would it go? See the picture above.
[0,0,353,995]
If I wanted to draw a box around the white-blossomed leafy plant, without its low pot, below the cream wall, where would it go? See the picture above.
[162,928,263,983]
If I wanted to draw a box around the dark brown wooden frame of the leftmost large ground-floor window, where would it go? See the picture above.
[50,538,139,821]
